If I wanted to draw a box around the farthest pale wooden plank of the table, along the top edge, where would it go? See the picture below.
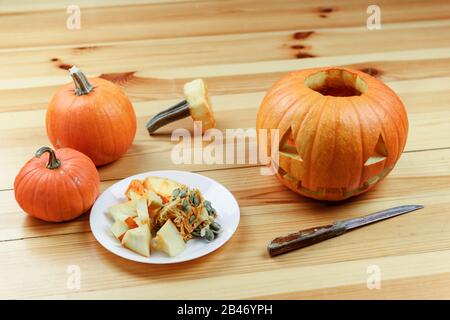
[0,0,449,48]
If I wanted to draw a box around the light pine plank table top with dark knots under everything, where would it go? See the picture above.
[0,0,450,299]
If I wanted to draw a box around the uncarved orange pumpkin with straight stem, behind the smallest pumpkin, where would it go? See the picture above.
[46,67,136,165]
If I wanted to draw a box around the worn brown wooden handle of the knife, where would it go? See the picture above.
[267,222,346,257]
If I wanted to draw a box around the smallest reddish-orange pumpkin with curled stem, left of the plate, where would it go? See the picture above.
[14,147,100,222]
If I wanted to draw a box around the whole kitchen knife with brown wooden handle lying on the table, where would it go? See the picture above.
[267,205,423,257]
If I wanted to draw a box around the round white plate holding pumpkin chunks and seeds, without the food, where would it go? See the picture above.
[89,170,240,264]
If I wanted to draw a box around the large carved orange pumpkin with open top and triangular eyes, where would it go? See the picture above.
[256,67,408,200]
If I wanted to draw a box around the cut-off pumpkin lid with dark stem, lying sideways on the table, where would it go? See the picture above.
[146,79,216,134]
